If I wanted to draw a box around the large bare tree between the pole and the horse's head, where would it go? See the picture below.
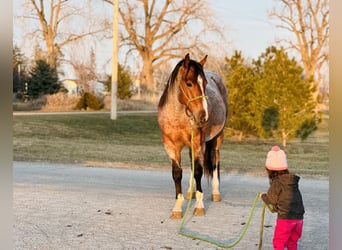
[104,0,223,100]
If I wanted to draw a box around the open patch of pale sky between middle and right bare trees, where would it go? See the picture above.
[212,0,283,58]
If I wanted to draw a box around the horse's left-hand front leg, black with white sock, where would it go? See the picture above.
[170,159,184,219]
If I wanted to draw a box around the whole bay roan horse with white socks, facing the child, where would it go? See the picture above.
[158,54,228,219]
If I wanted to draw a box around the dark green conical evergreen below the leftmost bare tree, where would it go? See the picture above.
[27,60,61,99]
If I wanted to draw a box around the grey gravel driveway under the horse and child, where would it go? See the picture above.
[13,162,329,250]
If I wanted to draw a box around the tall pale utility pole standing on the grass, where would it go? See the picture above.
[110,0,119,120]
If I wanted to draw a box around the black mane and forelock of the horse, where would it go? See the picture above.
[158,59,205,108]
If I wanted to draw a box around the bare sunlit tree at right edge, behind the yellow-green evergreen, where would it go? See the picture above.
[270,0,329,101]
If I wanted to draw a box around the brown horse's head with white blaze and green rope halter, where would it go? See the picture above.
[178,54,209,127]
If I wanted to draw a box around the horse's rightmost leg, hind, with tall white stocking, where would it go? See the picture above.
[211,132,223,201]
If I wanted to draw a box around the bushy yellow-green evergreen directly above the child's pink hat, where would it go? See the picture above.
[253,47,319,146]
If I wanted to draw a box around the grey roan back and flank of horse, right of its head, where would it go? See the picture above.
[205,71,228,141]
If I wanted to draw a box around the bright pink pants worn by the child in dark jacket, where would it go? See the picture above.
[273,219,303,250]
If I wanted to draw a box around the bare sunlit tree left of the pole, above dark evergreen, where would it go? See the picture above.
[20,0,110,68]
